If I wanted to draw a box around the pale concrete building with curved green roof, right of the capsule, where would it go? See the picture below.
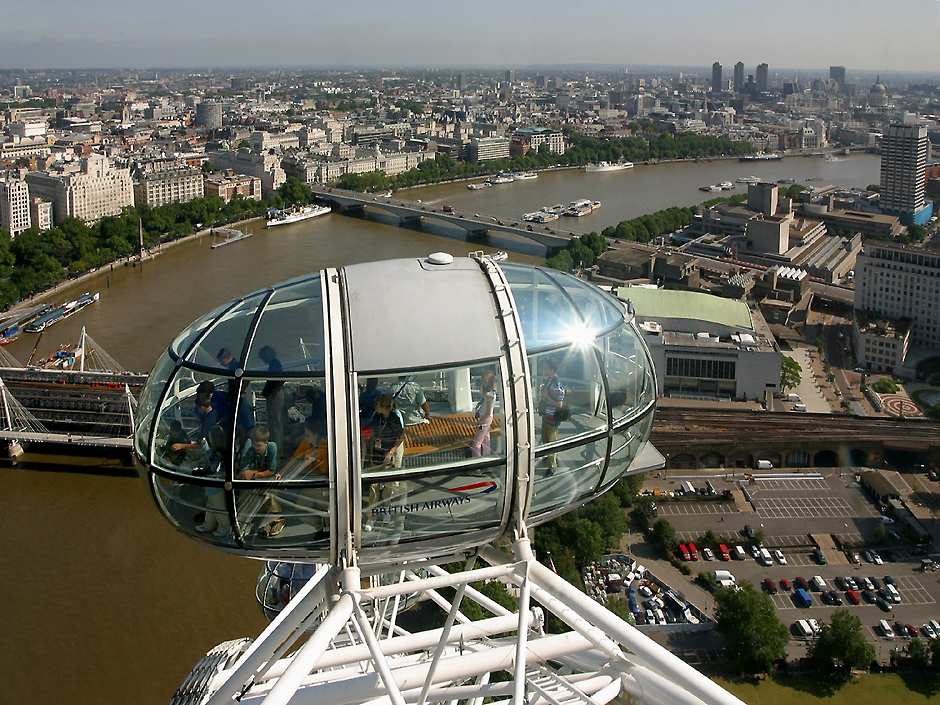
[618,287,780,401]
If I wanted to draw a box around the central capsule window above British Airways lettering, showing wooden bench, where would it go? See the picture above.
[359,362,506,474]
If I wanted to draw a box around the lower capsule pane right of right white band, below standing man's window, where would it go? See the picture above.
[530,435,607,514]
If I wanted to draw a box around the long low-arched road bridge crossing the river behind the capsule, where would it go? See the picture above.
[310,184,580,256]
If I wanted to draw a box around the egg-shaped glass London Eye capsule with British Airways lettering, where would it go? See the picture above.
[135,253,661,569]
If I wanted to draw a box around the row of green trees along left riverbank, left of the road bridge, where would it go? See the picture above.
[0,178,320,309]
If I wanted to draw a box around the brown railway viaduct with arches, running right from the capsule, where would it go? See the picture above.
[650,408,940,468]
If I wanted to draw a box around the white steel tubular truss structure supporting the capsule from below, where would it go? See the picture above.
[191,536,743,705]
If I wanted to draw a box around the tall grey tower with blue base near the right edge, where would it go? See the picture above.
[881,113,931,223]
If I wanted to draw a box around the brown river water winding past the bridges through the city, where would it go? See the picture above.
[0,150,879,705]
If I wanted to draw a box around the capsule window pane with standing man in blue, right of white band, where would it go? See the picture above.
[529,341,607,449]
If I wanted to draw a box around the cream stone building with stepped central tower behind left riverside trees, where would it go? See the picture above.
[26,153,134,224]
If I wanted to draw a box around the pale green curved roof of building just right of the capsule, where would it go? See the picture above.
[617,286,754,330]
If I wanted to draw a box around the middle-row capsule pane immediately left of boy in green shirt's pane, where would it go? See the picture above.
[154,367,238,479]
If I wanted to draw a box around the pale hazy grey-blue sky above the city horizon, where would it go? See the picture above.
[0,0,940,72]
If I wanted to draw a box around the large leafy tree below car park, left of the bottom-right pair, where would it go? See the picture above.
[715,583,790,673]
